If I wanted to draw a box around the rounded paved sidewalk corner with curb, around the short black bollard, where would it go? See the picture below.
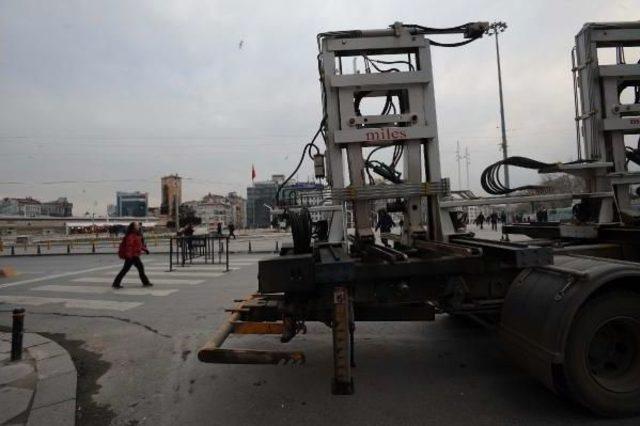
[0,332,77,426]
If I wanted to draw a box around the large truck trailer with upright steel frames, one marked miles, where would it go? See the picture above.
[198,23,640,415]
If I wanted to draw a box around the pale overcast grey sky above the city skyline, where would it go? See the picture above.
[0,0,640,215]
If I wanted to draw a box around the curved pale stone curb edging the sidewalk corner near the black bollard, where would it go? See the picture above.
[0,333,78,426]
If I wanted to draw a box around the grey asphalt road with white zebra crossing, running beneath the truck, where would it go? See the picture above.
[0,231,639,426]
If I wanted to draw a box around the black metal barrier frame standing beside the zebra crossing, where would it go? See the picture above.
[169,234,229,272]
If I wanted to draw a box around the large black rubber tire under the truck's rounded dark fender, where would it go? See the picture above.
[564,291,640,417]
